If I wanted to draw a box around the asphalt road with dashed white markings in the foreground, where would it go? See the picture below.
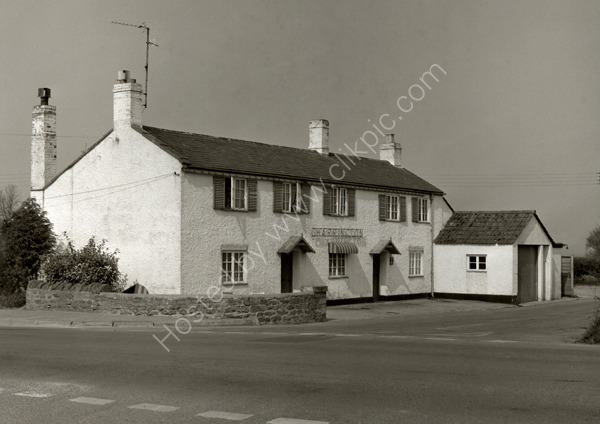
[0,300,600,424]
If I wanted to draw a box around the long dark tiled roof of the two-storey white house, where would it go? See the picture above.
[136,126,443,194]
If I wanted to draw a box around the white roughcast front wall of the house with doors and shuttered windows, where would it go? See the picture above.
[181,173,443,299]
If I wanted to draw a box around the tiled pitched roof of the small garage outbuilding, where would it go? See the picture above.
[434,211,552,244]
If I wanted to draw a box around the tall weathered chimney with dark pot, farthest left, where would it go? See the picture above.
[31,88,56,190]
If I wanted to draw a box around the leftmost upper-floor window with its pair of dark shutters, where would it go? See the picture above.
[213,175,257,211]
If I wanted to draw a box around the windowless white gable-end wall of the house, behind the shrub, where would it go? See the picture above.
[32,127,181,294]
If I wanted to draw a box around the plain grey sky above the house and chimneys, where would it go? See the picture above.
[0,0,600,255]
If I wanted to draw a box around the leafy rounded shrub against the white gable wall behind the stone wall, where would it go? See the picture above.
[40,237,125,291]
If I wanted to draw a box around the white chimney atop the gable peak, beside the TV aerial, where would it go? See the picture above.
[113,71,144,130]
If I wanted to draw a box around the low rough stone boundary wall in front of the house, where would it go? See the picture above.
[26,281,327,324]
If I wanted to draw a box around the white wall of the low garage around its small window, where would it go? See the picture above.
[434,244,517,296]
